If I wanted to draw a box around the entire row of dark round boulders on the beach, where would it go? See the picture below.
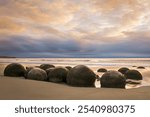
[4,63,143,88]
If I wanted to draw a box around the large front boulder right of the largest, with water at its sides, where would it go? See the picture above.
[100,71,126,88]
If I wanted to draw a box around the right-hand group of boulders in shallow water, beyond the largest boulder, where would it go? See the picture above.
[97,67,144,88]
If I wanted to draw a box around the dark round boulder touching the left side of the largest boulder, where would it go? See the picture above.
[48,67,68,83]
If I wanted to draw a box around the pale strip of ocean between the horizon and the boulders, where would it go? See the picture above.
[0,58,150,67]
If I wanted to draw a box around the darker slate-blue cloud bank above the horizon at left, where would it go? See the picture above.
[0,36,80,57]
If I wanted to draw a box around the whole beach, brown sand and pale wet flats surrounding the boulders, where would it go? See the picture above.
[0,59,150,100]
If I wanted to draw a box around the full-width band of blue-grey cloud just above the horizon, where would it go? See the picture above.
[0,36,150,57]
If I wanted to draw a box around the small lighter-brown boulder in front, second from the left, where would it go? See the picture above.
[27,68,47,81]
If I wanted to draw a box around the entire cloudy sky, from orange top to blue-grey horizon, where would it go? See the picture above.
[0,0,150,57]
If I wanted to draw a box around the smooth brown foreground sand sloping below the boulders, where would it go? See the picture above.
[0,60,150,100]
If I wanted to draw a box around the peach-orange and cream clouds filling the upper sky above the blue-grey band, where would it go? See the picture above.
[0,0,150,43]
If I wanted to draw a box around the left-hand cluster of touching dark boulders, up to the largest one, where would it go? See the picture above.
[4,63,98,87]
